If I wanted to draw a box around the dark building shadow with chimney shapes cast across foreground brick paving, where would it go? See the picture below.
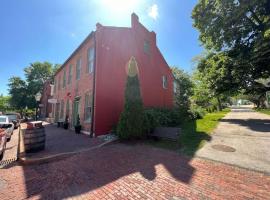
[16,119,211,199]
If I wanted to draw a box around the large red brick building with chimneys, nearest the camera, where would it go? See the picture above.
[53,14,173,136]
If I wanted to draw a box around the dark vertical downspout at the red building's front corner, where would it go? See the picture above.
[90,32,97,138]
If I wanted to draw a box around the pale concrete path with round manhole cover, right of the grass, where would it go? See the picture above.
[196,108,270,174]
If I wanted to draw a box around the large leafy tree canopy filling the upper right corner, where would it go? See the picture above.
[192,0,270,103]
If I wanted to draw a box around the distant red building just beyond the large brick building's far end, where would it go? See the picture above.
[39,81,53,118]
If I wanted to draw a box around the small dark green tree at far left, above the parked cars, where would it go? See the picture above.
[8,76,29,113]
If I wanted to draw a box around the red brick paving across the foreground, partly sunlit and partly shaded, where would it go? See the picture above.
[0,144,270,200]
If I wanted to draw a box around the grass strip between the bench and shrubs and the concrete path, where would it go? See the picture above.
[145,109,230,156]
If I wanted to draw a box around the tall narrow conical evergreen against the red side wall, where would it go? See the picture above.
[117,57,144,139]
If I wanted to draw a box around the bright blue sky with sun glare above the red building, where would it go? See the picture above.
[0,0,203,95]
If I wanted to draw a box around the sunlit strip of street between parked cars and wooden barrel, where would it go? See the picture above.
[0,126,19,168]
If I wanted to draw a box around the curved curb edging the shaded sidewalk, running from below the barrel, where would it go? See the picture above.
[18,140,117,166]
